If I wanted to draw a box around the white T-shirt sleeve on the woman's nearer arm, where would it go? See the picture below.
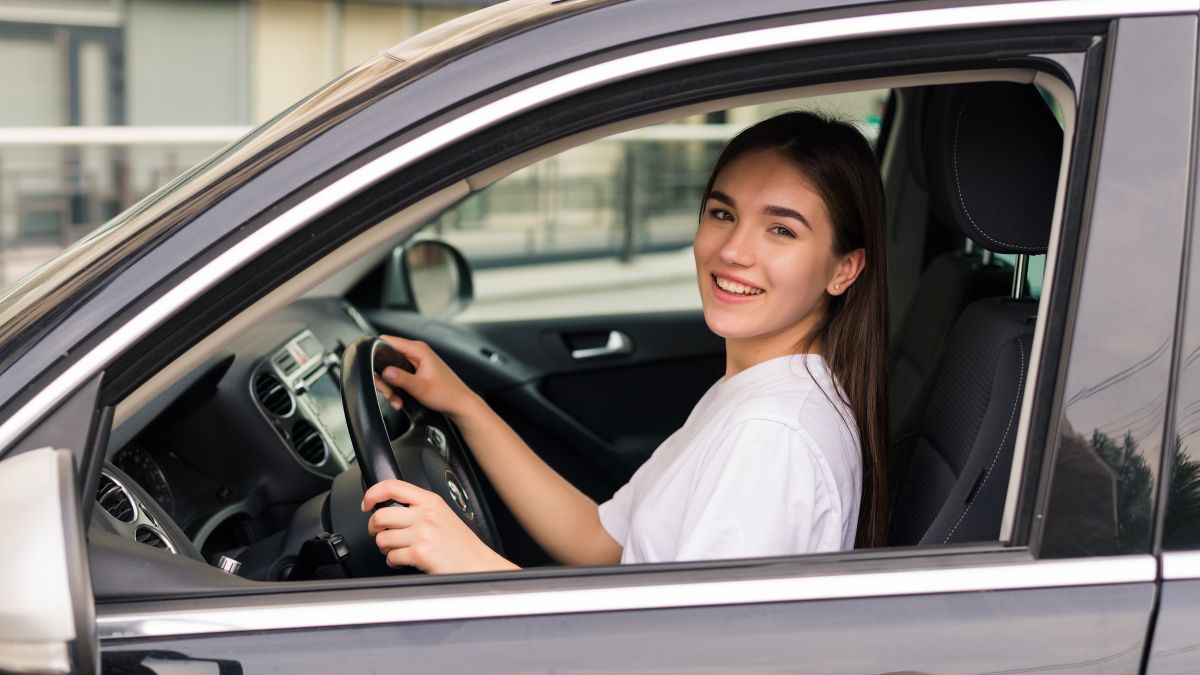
[677,419,842,560]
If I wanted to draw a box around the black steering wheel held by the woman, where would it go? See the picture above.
[342,338,503,561]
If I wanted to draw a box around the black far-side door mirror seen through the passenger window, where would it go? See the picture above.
[383,239,475,318]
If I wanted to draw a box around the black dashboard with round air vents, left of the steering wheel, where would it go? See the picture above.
[91,298,374,569]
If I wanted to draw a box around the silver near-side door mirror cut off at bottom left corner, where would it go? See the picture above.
[0,448,100,673]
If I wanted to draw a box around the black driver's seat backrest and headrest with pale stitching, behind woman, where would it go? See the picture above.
[890,83,1062,545]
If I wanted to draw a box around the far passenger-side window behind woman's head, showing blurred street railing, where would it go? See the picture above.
[412,90,888,322]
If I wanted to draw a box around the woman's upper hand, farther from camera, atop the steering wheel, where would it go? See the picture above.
[376,335,480,419]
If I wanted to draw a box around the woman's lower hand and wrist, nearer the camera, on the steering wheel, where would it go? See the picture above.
[362,479,516,574]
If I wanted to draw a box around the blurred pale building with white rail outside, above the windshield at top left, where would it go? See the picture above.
[0,0,493,287]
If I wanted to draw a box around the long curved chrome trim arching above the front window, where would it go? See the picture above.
[0,0,1200,448]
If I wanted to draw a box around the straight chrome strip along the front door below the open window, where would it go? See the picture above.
[97,555,1158,640]
